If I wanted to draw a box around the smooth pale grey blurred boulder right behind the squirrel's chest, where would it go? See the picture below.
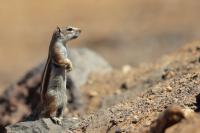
[69,48,112,86]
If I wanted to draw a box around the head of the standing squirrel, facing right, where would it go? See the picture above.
[54,26,81,43]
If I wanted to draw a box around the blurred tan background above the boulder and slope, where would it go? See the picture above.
[0,0,200,88]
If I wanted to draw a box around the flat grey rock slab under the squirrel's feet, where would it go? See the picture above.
[4,118,79,133]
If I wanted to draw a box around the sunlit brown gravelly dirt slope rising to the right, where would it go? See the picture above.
[69,42,200,133]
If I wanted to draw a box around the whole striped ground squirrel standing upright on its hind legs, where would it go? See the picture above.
[39,27,81,125]
